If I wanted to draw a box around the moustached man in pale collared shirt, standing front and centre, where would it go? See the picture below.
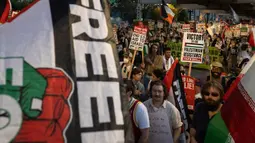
[144,81,183,143]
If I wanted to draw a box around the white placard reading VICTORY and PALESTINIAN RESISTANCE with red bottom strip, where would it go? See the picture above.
[181,32,204,63]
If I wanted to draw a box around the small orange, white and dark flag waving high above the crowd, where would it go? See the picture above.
[161,0,175,24]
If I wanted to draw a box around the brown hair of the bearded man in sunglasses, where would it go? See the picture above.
[201,80,224,98]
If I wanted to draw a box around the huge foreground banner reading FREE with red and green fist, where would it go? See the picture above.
[0,0,125,143]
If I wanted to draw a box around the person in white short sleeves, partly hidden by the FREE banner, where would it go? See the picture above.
[125,81,150,143]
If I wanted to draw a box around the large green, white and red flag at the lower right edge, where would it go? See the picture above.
[205,56,255,143]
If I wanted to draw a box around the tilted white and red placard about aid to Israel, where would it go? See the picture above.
[129,26,147,51]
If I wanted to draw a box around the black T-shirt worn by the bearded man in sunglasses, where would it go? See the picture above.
[192,102,210,143]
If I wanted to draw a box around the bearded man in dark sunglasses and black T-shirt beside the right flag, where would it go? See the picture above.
[190,81,224,143]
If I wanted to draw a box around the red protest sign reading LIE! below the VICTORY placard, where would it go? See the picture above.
[182,76,196,110]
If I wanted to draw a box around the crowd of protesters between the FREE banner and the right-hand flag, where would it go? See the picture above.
[117,20,252,143]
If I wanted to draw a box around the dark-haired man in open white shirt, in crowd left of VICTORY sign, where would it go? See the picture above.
[163,48,174,71]
